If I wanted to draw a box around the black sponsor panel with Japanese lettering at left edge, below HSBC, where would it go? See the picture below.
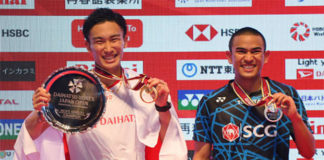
[0,61,35,81]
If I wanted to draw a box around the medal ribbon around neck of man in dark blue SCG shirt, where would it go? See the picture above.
[231,78,273,106]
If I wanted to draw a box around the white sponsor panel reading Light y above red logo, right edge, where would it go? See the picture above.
[285,58,324,79]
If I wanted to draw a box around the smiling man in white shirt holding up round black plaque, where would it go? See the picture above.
[14,8,187,160]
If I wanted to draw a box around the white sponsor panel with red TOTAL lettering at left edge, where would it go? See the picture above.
[0,90,34,111]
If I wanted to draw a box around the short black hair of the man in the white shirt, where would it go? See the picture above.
[83,8,127,42]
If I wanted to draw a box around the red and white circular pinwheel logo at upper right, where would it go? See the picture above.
[290,22,310,41]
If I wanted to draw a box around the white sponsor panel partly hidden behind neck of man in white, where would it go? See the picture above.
[66,61,143,74]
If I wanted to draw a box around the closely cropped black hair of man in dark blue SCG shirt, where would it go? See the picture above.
[228,27,267,52]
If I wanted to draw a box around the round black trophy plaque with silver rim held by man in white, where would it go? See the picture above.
[42,67,106,133]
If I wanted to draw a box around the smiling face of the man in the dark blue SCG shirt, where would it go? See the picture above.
[227,34,269,80]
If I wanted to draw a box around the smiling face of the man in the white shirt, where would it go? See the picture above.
[86,21,127,75]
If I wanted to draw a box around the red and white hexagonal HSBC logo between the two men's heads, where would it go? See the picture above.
[186,24,218,41]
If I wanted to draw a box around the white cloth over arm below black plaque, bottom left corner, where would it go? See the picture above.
[14,123,65,160]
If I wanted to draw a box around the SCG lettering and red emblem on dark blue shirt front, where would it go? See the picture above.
[222,123,277,142]
